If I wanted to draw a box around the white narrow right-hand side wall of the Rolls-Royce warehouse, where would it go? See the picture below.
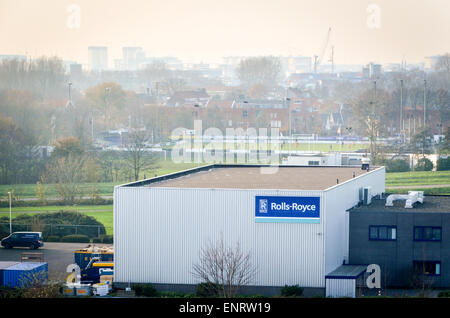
[323,167,385,274]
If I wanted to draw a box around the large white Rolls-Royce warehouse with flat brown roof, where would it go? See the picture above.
[114,164,385,295]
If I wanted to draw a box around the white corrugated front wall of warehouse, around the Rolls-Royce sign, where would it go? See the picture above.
[114,187,325,287]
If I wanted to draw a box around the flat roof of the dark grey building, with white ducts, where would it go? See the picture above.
[350,195,450,213]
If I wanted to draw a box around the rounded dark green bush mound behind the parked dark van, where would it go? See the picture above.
[0,211,106,240]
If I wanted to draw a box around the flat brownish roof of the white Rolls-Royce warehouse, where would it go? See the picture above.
[145,165,377,190]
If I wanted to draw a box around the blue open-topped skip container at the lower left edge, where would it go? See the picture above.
[0,262,48,288]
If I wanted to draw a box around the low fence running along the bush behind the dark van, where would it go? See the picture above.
[0,222,113,238]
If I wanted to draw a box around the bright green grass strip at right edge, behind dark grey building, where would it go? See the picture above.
[386,171,450,188]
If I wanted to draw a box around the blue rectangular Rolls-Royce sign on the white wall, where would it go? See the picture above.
[255,196,320,223]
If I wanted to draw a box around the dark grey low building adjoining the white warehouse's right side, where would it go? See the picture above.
[349,196,450,288]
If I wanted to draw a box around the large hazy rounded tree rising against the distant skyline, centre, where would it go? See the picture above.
[237,56,281,87]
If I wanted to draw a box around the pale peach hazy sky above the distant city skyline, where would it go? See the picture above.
[0,0,450,65]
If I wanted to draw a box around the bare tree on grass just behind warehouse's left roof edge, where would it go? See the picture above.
[124,129,157,181]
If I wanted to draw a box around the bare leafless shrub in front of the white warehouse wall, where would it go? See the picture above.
[193,235,256,297]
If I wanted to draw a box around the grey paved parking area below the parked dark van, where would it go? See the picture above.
[0,242,112,280]
